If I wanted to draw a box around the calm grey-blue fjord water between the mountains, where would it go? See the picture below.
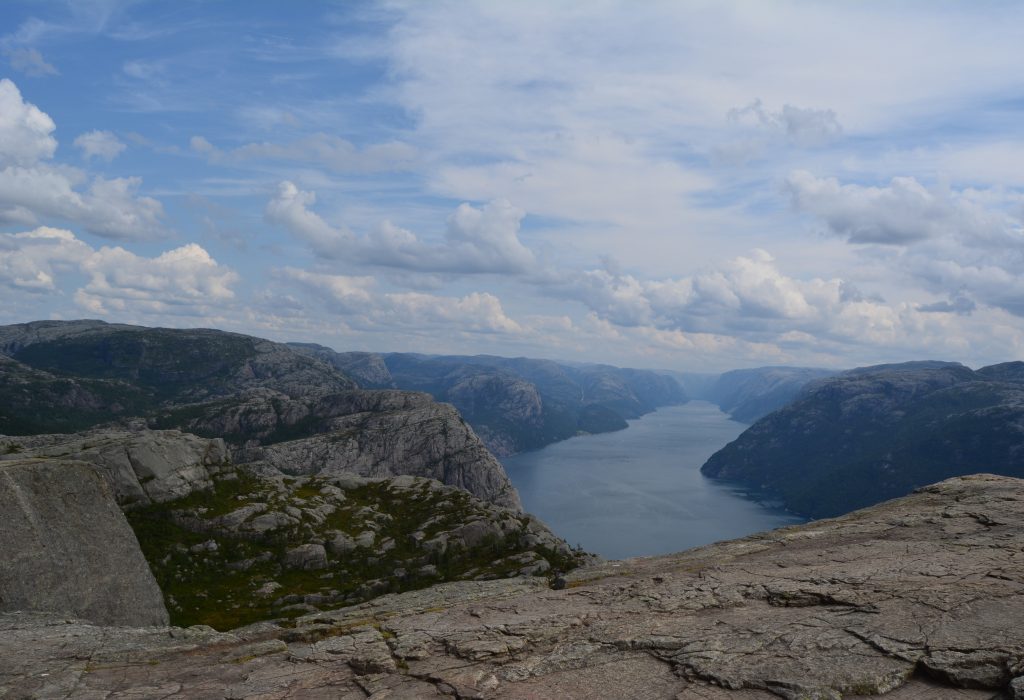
[502,401,803,559]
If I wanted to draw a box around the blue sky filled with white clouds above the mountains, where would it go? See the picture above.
[0,0,1024,371]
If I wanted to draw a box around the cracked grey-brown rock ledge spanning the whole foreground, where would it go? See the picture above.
[0,475,1024,700]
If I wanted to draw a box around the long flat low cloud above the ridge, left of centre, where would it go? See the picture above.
[280,267,522,334]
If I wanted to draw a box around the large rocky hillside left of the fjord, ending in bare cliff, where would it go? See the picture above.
[0,320,521,509]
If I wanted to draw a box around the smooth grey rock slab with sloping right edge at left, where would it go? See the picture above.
[0,460,168,626]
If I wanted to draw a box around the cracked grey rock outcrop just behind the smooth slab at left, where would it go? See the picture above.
[0,429,229,508]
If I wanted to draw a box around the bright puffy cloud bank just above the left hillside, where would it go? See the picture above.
[0,226,239,314]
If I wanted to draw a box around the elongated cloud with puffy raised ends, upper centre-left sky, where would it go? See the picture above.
[265,182,537,274]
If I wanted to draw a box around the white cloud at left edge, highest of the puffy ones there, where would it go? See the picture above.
[0,80,164,240]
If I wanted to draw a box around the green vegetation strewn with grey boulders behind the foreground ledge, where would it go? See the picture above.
[128,471,582,629]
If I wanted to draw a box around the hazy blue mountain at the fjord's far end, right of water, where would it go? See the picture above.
[679,367,837,423]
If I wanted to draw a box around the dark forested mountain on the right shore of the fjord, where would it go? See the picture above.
[701,361,1024,518]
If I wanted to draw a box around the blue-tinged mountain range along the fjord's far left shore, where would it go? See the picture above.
[293,344,686,456]
